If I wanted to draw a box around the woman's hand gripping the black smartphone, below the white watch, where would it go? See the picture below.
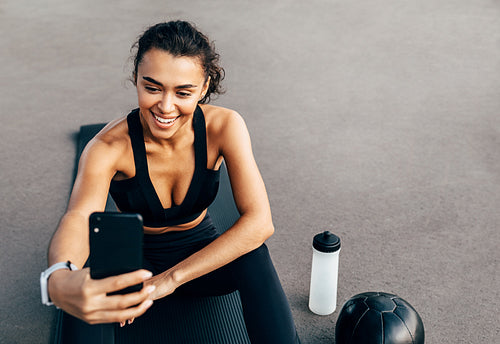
[48,268,155,324]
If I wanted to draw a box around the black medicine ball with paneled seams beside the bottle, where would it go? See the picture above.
[335,292,424,344]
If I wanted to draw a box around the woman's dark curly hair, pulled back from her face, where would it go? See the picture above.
[131,20,224,104]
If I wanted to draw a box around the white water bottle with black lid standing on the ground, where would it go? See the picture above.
[309,231,340,315]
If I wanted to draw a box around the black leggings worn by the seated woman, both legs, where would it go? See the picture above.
[60,214,299,344]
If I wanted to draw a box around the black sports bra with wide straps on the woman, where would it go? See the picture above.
[109,106,219,227]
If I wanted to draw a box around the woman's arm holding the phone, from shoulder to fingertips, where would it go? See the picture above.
[48,133,151,324]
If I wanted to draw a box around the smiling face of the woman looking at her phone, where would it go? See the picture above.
[136,49,210,139]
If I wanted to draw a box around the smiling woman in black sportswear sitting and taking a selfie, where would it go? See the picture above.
[44,21,296,343]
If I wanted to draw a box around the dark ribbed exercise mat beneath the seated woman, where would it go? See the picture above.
[54,124,250,344]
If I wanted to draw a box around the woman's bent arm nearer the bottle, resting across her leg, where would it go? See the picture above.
[149,111,274,298]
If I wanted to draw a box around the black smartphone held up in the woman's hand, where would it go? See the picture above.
[89,212,144,295]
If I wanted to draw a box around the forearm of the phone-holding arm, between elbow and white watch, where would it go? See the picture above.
[48,212,89,268]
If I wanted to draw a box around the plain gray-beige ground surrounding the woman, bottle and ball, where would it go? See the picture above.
[0,0,500,343]
